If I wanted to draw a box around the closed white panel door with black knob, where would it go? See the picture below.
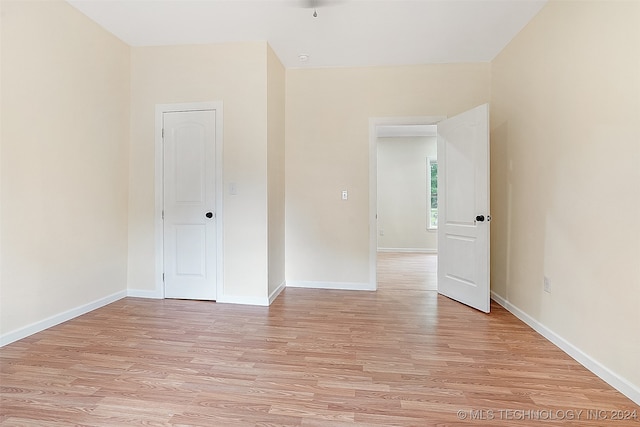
[162,110,216,300]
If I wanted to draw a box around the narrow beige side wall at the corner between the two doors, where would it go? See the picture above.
[267,46,285,295]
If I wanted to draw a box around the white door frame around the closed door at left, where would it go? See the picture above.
[154,101,224,299]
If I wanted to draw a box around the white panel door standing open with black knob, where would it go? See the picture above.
[438,104,491,313]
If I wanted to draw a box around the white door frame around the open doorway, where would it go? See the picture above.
[369,116,447,290]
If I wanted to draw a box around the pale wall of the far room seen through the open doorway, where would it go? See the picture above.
[377,136,438,252]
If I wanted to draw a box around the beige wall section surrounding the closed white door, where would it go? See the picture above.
[128,42,268,301]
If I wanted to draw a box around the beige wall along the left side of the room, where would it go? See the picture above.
[0,1,129,335]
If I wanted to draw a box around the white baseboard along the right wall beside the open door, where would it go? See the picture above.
[491,292,640,405]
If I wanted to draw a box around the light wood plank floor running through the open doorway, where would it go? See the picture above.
[0,255,640,427]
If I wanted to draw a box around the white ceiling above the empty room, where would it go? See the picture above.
[68,0,546,68]
